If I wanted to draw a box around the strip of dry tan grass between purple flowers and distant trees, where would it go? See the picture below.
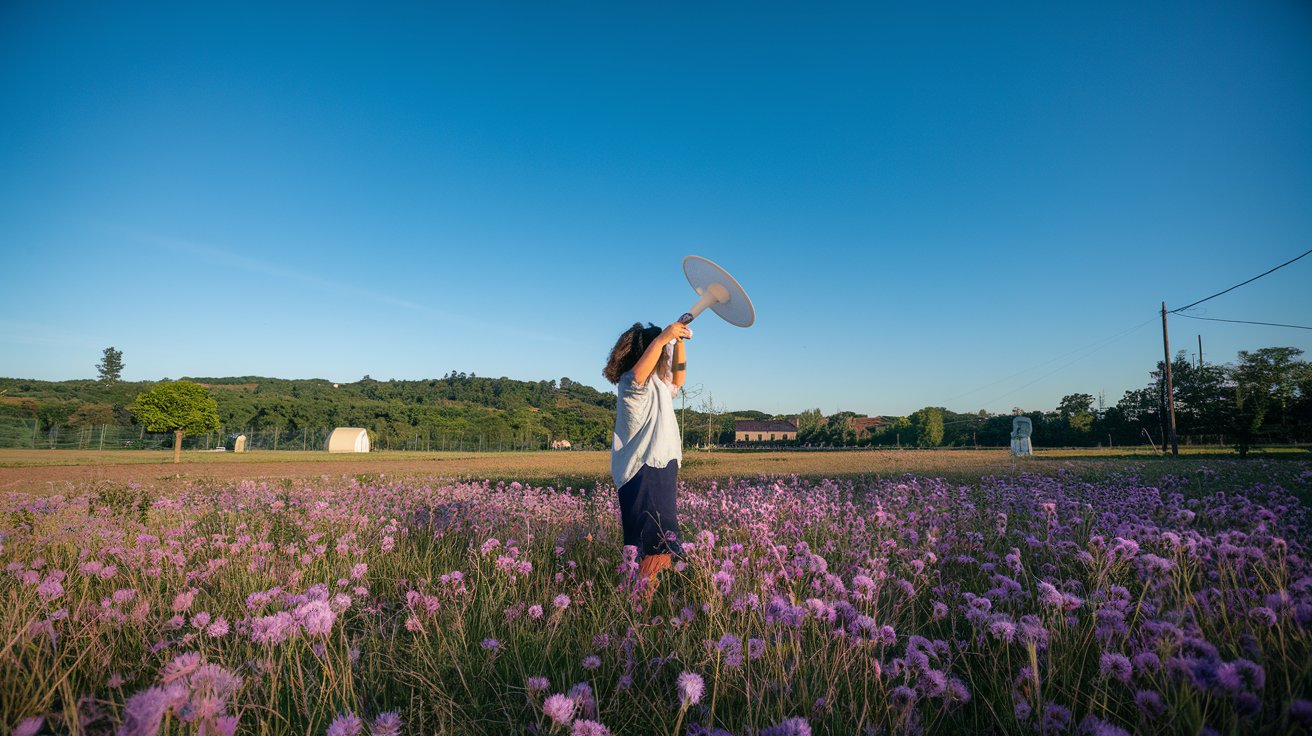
[0,440,1308,491]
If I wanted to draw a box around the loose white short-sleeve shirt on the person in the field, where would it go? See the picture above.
[610,371,684,488]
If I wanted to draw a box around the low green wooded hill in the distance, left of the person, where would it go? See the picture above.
[0,373,615,449]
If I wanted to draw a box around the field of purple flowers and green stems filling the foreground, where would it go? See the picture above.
[0,460,1312,736]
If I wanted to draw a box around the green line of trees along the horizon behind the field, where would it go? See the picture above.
[0,348,1312,451]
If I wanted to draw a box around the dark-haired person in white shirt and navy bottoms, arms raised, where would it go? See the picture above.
[601,321,693,598]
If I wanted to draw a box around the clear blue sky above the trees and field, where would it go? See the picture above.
[0,0,1312,415]
